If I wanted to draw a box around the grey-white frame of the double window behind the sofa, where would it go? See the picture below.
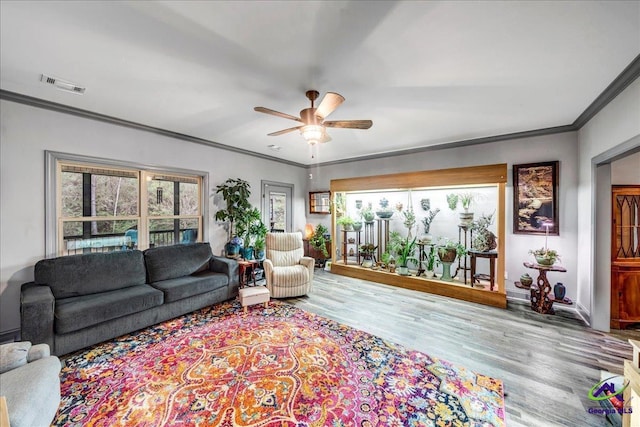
[45,151,209,258]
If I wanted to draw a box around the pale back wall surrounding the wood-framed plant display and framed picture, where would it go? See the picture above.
[308,132,578,300]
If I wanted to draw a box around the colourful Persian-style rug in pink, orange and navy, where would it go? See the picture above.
[54,302,504,427]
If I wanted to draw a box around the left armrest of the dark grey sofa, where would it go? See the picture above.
[20,282,55,348]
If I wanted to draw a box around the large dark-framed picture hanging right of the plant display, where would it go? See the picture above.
[513,161,560,236]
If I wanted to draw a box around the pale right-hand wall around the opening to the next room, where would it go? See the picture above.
[577,79,640,331]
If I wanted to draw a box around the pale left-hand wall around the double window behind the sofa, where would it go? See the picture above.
[0,100,307,334]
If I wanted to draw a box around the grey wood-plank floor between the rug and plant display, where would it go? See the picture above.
[285,269,640,427]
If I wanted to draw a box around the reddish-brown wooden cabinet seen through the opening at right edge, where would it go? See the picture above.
[611,185,640,329]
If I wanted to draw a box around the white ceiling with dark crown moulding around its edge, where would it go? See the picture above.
[0,0,640,164]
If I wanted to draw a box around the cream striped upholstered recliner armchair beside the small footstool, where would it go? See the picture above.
[263,232,315,298]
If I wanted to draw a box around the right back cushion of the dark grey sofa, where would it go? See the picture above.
[144,243,212,283]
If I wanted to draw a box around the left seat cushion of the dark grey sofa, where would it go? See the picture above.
[55,285,164,334]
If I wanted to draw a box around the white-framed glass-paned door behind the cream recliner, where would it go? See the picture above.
[262,181,293,232]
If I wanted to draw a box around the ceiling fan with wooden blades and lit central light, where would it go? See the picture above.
[254,90,373,145]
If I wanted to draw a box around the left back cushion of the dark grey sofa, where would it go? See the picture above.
[34,250,146,299]
